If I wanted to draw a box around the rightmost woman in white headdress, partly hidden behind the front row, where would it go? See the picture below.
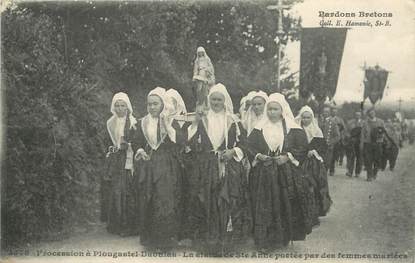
[295,106,332,225]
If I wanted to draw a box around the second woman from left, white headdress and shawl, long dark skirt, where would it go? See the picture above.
[135,87,181,247]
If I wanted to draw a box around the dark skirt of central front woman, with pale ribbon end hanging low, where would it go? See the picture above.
[188,152,251,251]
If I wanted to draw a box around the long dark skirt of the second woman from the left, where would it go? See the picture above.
[136,148,182,247]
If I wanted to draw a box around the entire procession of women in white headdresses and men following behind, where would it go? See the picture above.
[101,84,399,253]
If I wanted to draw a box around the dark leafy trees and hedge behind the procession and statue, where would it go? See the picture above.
[2,0,299,249]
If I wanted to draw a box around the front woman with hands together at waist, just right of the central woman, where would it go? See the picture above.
[243,93,311,249]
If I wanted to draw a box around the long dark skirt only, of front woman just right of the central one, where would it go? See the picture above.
[251,163,312,249]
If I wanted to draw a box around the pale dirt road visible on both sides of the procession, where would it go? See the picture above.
[4,146,415,262]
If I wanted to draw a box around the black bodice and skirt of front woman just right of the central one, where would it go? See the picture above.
[243,121,311,249]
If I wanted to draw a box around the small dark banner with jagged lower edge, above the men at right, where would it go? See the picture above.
[363,65,389,104]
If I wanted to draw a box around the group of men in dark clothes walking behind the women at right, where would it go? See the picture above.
[320,104,403,181]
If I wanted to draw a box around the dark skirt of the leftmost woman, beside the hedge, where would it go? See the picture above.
[105,151,138,236]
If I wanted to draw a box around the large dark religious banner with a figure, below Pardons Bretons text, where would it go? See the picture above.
[300,27,347,103]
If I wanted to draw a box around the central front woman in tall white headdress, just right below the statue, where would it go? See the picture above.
[188,84,251,251]
